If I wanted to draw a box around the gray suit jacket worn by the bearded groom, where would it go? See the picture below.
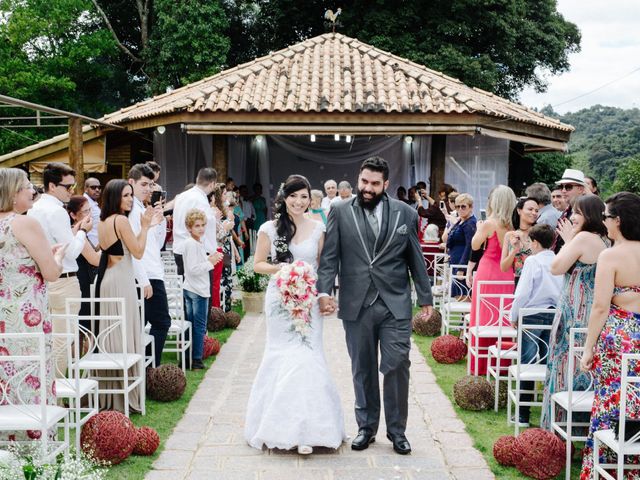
[317,195,432,321]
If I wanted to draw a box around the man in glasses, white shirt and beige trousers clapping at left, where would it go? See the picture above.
[27,162,93,376]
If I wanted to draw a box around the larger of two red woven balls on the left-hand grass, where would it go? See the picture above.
[80,410,136,465]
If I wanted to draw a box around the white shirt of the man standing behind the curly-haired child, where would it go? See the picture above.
[173,185,218,255]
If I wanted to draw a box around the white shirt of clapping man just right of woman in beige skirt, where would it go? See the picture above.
[129,198,167,287]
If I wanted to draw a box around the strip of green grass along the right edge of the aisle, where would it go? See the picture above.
[413,334,582,480]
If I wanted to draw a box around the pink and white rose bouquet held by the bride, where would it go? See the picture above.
[275,260,317,344]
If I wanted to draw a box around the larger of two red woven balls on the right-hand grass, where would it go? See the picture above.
[513,428,565,480]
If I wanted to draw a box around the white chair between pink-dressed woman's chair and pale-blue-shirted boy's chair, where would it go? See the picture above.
[484,294,518,412]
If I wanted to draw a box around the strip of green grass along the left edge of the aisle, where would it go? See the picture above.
[101,304,244,480]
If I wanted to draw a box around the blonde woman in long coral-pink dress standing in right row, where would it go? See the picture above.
[469,185,517,375]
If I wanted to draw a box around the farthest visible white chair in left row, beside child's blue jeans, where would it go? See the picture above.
[164,275,192,371]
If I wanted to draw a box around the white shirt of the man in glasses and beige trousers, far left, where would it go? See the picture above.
[27,193,87,273]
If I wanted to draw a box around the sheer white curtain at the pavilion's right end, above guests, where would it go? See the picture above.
[444,135,509,210]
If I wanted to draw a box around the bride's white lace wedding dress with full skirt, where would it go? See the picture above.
[244,222,345,449]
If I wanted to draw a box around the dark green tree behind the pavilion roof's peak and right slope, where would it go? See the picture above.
[224,0,580,98]
